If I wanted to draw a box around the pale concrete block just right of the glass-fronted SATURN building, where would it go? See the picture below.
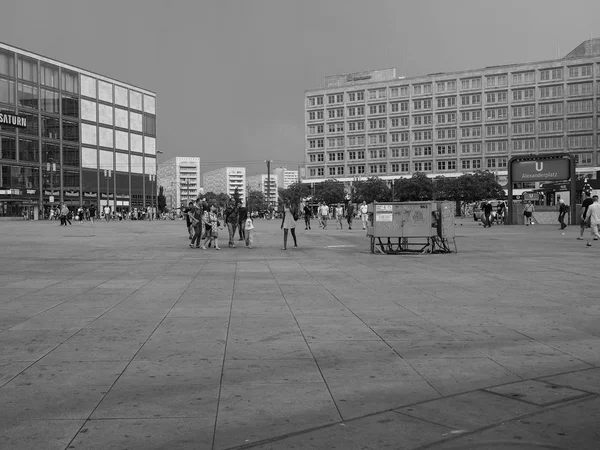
[158,156,201,209]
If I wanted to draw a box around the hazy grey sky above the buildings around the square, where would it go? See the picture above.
[0,0,600,175]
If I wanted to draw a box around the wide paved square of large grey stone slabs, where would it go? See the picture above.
[0,220,600,449]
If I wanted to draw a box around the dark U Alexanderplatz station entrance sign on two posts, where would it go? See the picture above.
[508,153,577,225]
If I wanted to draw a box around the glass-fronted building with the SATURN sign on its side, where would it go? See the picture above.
[0,43,156,218]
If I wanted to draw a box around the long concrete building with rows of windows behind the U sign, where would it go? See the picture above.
[303,39,600,187]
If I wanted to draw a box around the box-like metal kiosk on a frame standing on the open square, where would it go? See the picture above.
[367,201,458,255]
